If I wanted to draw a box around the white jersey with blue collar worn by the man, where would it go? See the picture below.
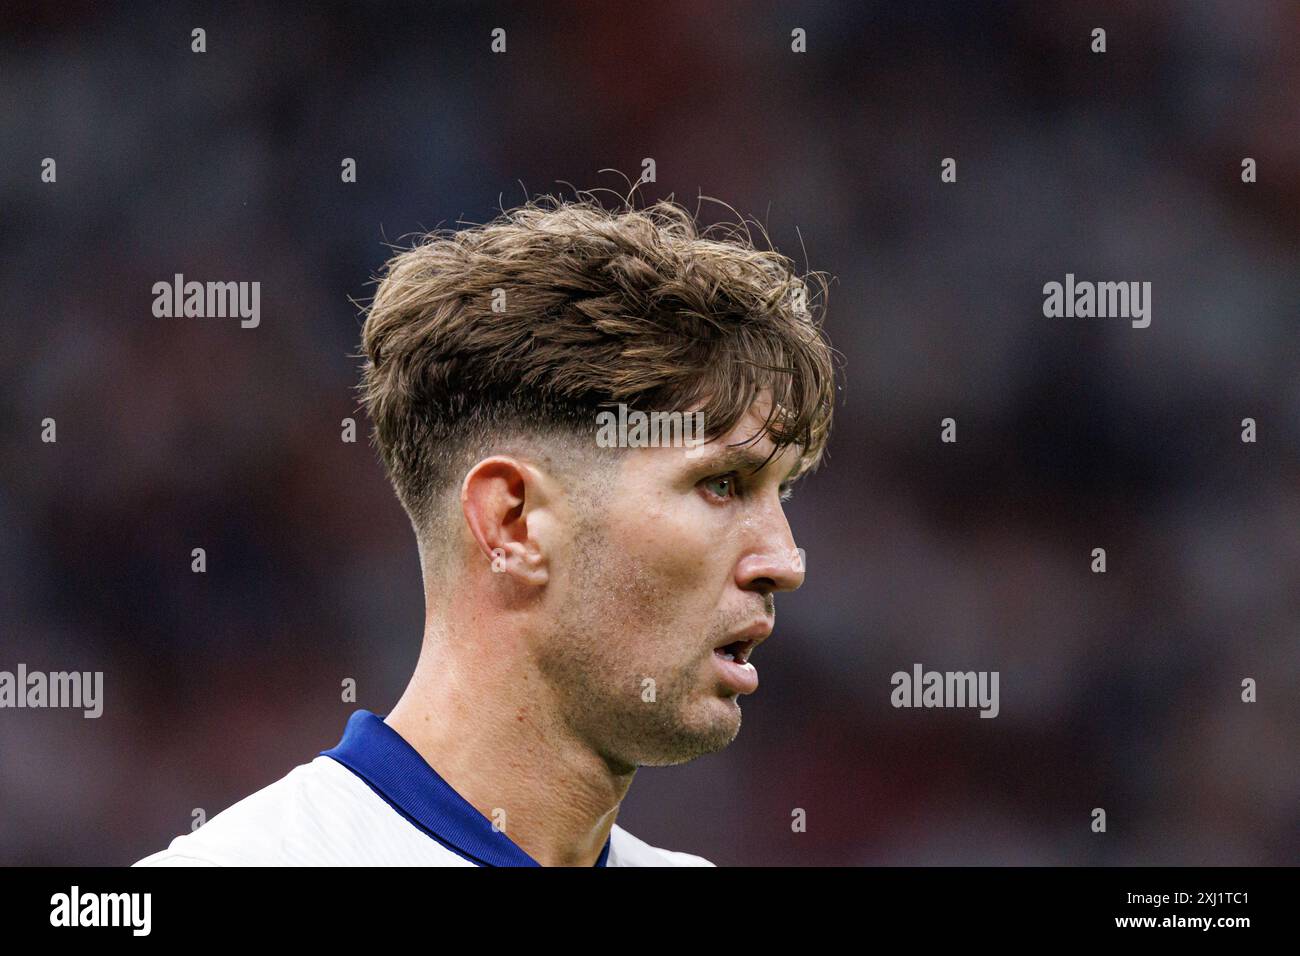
[135,710,714,866]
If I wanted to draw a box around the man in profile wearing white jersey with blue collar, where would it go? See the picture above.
[140,196,833,866]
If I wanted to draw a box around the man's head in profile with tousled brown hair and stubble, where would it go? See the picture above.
[363,200,835,767]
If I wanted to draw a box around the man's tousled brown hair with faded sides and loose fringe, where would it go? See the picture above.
[360,193,835,546]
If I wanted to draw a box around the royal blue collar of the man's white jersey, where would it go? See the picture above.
[321,710,610,866]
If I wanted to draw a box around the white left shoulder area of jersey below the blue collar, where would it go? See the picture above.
[134,756,475,866]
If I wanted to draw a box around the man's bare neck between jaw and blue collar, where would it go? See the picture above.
[385,619,636,866]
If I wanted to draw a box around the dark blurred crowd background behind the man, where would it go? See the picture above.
[0,0,1300,865]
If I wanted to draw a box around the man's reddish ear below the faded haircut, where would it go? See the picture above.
[460,455,549,587]
